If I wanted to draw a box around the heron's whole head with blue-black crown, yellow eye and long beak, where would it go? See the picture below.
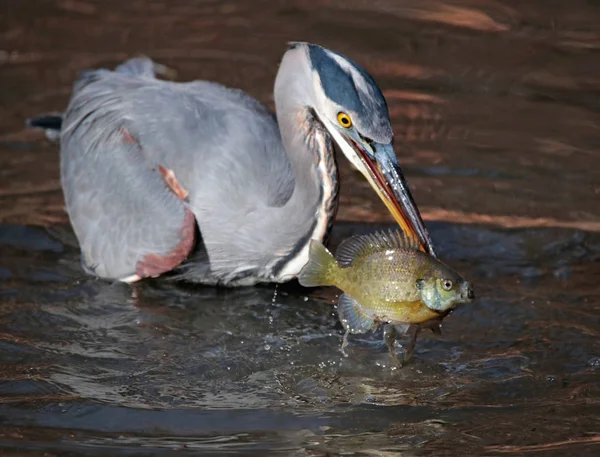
[288,43,435,255]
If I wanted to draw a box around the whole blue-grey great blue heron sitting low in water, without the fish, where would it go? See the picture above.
[29,43,435,286]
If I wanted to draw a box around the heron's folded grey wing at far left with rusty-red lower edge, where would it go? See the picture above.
[61,59,196,280]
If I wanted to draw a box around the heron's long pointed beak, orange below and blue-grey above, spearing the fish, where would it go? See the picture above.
[344,135,436,257]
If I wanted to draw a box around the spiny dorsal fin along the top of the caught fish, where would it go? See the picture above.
[335,229,419,267]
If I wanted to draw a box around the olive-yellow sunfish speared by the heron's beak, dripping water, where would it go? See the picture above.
[298,230,475,366]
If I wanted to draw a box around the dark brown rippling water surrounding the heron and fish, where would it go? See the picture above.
[0,0,600,456]
